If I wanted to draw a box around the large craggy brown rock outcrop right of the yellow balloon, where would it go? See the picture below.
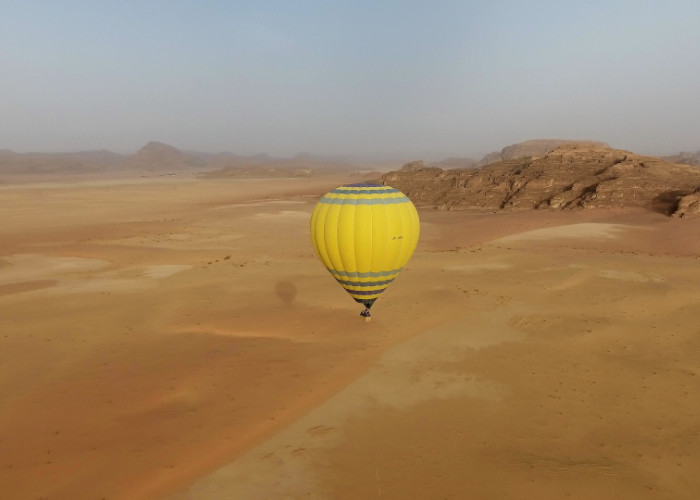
[383,144,700,214]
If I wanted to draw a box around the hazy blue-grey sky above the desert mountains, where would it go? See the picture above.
[0,0,700,156]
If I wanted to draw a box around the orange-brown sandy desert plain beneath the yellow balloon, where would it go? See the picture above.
[0,178,700,500]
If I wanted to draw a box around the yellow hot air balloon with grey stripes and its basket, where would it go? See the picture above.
[311,184,420,321]
